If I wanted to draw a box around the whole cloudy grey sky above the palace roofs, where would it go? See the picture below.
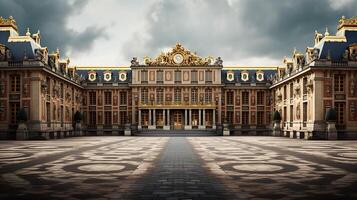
[0,0,357,66]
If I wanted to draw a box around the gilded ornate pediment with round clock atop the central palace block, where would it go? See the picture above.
[140,43,223,66]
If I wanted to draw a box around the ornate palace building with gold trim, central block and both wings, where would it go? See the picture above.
[0,17,357,139]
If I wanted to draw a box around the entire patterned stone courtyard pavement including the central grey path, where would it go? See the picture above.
[0,136,357,200]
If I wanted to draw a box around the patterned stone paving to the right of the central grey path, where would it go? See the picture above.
[189,137,357,199]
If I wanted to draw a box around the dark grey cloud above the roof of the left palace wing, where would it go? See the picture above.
[0,0,105,55]
